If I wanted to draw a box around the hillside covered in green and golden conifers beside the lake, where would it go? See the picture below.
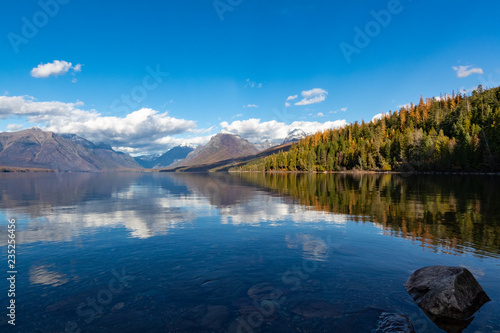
[236,86,500,171]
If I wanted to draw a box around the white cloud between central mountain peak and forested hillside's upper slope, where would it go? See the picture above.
[220,118,347,143]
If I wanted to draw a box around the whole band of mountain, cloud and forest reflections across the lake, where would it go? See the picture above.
[0,173,500,256]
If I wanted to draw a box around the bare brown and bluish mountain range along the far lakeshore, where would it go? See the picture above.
[0,128,294,172]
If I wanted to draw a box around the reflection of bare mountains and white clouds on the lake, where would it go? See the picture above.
[0,173,347,245]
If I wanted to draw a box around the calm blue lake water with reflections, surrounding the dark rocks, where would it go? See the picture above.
[0,173,500,333]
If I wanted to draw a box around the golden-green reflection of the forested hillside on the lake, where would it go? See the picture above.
[235,173,500,257]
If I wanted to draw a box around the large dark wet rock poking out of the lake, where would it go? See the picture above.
[405,266,490,324]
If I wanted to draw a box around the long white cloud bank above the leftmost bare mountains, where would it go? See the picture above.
[0,96,196,151]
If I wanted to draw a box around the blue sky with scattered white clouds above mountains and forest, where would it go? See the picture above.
[0,0,500,154]
